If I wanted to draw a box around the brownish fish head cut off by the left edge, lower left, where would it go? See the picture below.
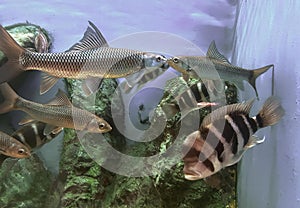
[0,132,30,158]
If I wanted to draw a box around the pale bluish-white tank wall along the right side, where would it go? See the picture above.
[233,0,300,208]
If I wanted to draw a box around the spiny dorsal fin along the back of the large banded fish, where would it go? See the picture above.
[201,99,254,127]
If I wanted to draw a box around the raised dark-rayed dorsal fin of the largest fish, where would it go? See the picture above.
[67,21,108,52]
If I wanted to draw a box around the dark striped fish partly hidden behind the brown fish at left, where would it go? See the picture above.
[0,122,63,165]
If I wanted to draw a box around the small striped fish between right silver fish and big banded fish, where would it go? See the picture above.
[161,82,218,120]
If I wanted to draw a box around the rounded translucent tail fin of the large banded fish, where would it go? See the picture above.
[256,96,284,128]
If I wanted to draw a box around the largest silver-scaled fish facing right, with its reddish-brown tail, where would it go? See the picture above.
[0,21,167,94]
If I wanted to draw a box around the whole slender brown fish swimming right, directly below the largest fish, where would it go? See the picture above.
[0,83,112,135]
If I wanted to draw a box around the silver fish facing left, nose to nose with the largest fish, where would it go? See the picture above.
[167,41,274,98]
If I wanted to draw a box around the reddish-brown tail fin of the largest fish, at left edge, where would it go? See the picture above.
[0,25,25,83]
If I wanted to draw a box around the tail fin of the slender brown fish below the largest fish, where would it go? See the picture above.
[0,82,19,114]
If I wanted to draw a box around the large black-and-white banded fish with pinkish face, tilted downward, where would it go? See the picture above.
[182,96,284,180]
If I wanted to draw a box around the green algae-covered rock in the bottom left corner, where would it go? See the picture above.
[0,155,54,208]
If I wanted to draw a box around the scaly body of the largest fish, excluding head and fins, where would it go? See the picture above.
[20,48,143,79]
